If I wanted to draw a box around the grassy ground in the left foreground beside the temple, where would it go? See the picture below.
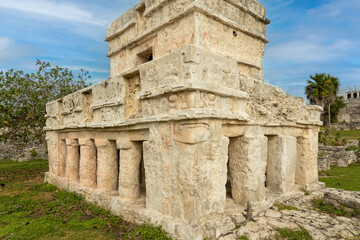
[0,160,170,240]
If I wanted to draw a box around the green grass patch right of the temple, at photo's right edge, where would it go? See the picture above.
[319,163,360,191]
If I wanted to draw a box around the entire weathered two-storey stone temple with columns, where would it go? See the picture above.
[46,0,322,239]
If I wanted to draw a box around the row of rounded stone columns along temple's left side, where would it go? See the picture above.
[58,138,142,200]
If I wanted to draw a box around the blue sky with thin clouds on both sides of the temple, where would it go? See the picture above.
[0,0,360,96]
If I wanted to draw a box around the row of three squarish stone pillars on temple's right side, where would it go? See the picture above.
[228,135,318,205]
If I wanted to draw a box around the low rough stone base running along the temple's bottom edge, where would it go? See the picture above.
[45,173,324,240]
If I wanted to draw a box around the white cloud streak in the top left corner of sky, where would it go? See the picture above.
[0,0,106,26]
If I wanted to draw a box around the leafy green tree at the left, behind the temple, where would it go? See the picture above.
[0,60,90,141]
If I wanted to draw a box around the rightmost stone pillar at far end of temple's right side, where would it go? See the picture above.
[295,129,318,185]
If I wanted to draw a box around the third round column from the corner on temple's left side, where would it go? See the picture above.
[79,138,96,188]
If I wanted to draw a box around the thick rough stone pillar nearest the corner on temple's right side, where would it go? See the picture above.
[229,131,267,206]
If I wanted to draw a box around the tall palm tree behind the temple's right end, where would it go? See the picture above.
[305,73,340,142]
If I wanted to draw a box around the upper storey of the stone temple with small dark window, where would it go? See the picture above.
[106,0,269,80]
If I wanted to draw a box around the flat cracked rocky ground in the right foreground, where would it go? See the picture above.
[218,189,360,240]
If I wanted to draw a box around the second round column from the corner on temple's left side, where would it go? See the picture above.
[95,139,119,193]
